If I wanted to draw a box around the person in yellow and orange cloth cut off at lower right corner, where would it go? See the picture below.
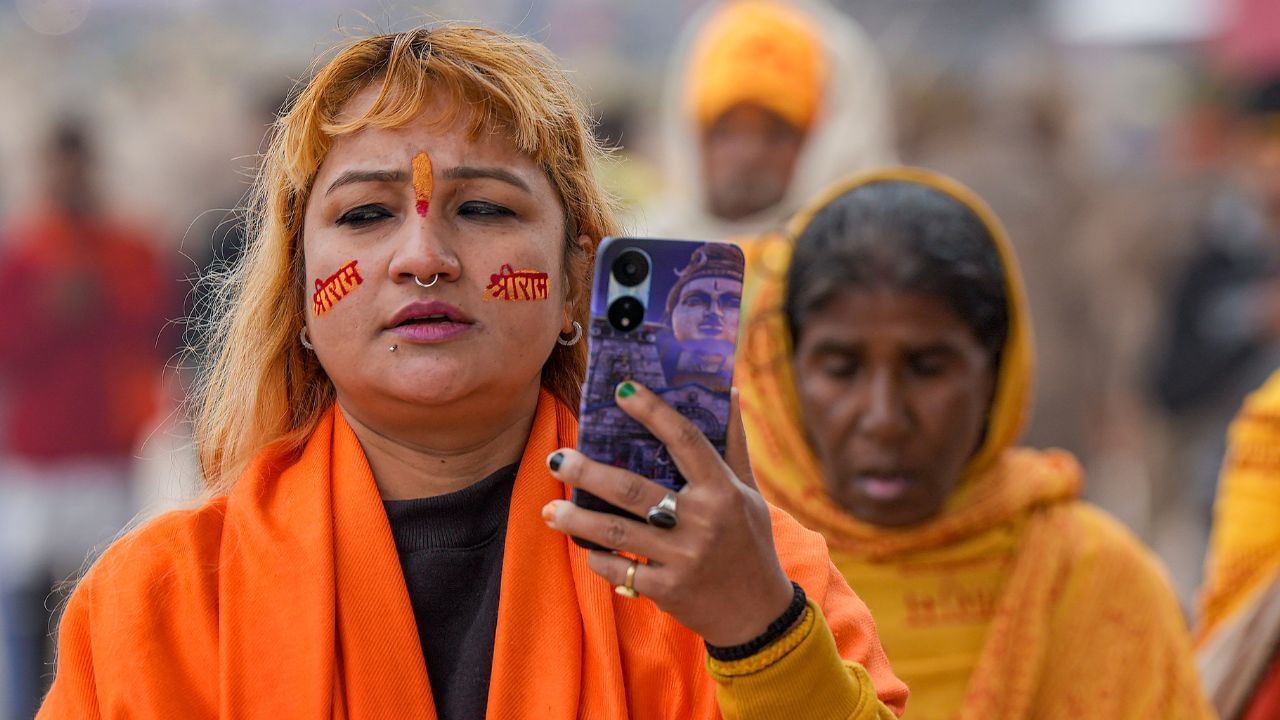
[1197,372,1280,720]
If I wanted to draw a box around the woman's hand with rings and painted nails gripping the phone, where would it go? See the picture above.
[543,382,794,647]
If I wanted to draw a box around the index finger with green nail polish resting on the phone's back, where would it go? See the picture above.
[614,380,728,484]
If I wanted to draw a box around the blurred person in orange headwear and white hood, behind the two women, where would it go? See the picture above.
[648,0,895,243]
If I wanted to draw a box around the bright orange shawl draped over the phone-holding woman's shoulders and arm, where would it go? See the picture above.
[41,391,906,720]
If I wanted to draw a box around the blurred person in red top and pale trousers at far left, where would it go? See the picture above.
[0,118,178,717]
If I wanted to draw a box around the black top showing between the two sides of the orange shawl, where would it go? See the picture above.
[384,465,518,720]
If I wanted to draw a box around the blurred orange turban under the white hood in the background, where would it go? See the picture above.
[689,0,827,129]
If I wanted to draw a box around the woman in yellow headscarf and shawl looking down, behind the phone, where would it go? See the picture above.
[739,168,1212,720]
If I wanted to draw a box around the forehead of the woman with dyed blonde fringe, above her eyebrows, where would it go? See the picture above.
[316,85,550,192]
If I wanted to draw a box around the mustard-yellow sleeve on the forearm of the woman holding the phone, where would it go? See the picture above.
[707,601,897,720]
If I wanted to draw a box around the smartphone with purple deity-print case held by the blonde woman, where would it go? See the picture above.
[572,237,745,550]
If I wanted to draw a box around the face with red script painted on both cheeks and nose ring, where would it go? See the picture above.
[303,87,571,414]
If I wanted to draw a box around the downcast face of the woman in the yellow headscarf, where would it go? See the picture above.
[795,288,996,527]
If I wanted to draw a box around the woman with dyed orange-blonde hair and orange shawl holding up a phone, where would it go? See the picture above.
[41,26,906,719]
